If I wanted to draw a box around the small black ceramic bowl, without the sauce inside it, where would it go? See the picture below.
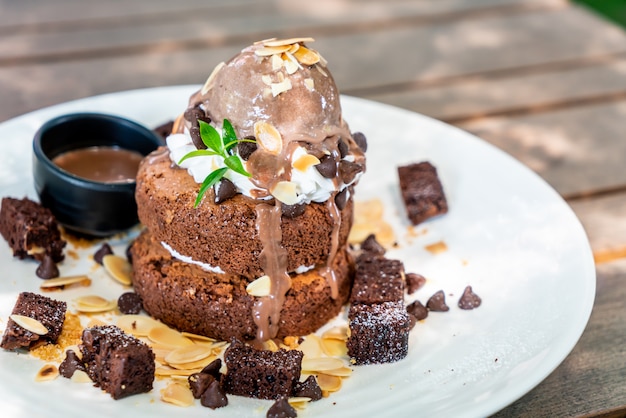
[33,113,163,237]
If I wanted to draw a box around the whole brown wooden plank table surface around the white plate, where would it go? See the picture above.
[0,0,626,417]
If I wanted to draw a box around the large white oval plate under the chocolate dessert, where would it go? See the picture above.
[0,86,595,418]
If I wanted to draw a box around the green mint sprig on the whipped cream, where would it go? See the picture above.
[178,119,256,208]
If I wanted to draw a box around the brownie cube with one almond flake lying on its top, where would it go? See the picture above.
[0,292,67,350]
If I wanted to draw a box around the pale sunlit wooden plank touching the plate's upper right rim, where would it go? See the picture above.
[459,100,626,197]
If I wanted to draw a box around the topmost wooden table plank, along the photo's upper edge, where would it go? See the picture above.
[0,0,565,28]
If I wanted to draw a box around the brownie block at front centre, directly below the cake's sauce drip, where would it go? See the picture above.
[221,339,303,399]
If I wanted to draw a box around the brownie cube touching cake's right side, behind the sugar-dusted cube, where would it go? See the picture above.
[350,256,404,304]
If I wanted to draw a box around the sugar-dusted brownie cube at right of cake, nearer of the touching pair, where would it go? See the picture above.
[347,302,411,364]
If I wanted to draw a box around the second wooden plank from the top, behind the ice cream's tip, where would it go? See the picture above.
[0,0,564,61]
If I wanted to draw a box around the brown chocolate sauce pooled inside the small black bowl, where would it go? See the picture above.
[52,147,143,183]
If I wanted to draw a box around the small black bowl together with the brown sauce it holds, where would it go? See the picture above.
[33,113,163,237]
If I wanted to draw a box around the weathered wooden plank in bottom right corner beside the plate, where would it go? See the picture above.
[493,260,626,418]
